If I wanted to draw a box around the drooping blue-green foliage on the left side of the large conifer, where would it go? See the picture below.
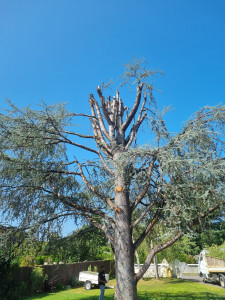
[0,99,83,234]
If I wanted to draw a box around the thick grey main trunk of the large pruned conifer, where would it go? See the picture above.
[115,156,137,300]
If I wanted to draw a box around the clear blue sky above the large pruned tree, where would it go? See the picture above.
[0,0,225,234]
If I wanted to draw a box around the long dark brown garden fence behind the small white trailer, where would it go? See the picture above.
[14,260,115,285]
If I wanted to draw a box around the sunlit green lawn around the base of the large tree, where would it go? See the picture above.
[26,279,225,300]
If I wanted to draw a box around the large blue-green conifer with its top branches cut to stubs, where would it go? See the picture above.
[0,60,225,300]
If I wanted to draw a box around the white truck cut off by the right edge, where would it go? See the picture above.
[198,250,225,288]
